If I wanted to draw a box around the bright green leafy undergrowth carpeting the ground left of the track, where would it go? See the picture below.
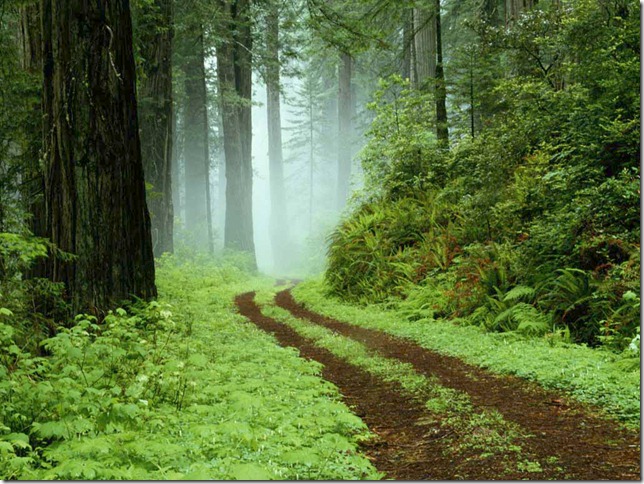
[0,259,379,480]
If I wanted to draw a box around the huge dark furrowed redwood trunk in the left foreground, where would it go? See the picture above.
[42,0,156,313]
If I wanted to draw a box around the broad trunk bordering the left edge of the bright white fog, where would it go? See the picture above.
[217,0,255,264]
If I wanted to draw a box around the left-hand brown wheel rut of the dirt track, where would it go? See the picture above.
[235,292,540,480]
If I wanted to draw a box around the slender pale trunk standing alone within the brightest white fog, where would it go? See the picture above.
[266,3,289,270]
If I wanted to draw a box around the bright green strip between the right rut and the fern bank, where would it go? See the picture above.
[293,280,640,428]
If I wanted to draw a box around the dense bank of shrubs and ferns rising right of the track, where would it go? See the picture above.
[325,0,640,351]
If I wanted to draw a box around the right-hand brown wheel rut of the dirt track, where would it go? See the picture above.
[275,290,640,480]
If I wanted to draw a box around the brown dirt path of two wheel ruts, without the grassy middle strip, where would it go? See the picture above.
[236,290,640,480]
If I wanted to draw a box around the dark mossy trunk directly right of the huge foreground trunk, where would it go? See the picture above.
[139,0,174,256]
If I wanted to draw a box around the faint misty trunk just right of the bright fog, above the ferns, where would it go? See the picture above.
[338,52,353,210]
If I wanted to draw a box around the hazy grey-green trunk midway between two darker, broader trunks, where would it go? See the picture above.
[183,30,213,252]
